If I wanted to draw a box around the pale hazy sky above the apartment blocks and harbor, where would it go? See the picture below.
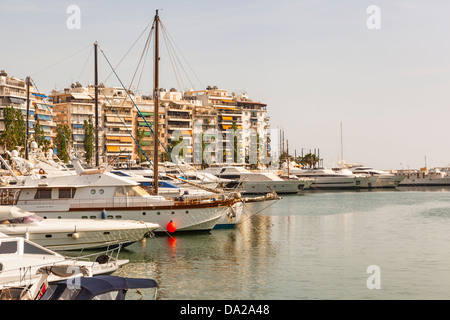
[0,0,450,169]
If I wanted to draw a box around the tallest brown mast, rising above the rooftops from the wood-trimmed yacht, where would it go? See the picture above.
[153,10,159,194]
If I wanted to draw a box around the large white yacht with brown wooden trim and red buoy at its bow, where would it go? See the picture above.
[0,161,241,232]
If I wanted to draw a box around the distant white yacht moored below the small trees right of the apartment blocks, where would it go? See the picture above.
[284,167,369,189]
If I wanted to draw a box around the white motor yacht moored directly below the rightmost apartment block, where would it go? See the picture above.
[204,166,307,194]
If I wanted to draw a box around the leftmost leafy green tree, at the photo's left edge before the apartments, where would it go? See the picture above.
[0,106,26,154]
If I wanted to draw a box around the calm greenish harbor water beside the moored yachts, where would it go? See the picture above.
[116,188,450,300]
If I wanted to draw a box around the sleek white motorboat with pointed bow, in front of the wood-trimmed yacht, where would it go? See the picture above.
[0,205,159,250]
